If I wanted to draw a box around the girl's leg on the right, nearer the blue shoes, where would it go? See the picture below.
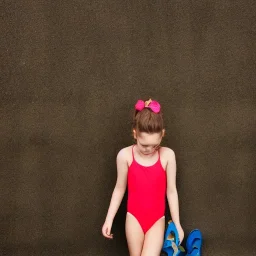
[141,217,165,256]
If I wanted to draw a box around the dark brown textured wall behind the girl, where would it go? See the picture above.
[0,0,256,256]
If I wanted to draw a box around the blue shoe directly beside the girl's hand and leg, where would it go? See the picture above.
[162,221,184,256]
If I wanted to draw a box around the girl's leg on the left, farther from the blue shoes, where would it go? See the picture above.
[125,213,144,256]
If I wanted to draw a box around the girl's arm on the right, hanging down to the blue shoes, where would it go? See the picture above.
[166,149,184,243]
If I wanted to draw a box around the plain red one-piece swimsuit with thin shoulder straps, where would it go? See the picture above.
[127,146,166,234]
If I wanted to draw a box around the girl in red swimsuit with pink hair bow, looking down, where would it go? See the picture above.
[102,99,184,256]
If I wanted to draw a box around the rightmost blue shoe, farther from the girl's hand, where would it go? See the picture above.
[186,229,203,256]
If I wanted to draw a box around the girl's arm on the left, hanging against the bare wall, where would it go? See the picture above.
[102,149,128,238]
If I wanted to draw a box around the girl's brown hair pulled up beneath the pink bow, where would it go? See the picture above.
[132,102,164,133]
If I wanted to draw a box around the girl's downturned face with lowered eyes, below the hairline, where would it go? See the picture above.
[133,131,163,155]
